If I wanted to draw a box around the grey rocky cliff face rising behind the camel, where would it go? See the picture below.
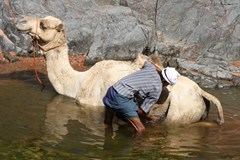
[0,0,240,87]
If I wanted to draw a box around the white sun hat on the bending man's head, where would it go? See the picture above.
[161,67,180,85]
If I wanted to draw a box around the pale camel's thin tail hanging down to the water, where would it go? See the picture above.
[202,90,224,125]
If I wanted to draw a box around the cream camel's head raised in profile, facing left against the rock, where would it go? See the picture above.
[17,16,64,45]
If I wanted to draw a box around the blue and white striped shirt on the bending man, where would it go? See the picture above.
[113,61,162,113]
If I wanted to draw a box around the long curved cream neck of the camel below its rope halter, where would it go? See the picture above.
[46,43,84,98]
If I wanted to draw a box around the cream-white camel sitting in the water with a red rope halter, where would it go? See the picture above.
[17,16,224,124]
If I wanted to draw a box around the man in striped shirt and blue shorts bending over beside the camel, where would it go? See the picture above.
[103,61,180,133]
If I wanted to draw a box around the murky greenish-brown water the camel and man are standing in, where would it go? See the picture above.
[0,76,240,160]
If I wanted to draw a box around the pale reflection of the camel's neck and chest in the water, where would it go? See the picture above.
[45,95,104,143]
